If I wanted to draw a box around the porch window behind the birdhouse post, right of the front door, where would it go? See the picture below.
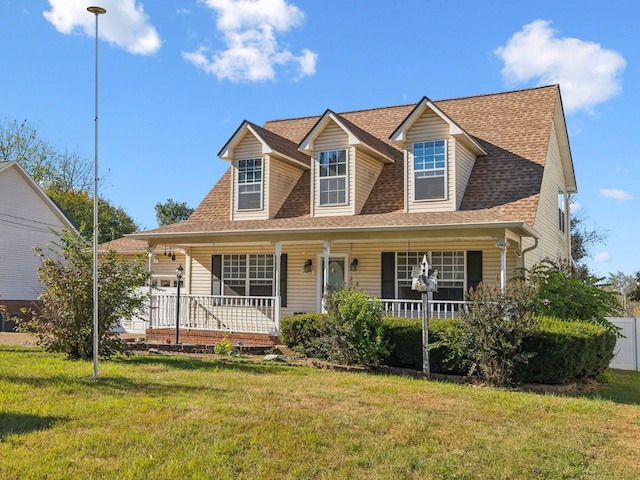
[396,251,465,300]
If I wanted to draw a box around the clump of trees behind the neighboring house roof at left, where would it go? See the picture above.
[0,118,138,242]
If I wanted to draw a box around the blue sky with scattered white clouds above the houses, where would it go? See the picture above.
[0,0,640,276]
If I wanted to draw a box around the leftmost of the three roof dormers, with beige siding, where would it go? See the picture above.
[218,120,311,220]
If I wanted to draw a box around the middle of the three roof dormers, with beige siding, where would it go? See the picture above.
[299,110,399,217]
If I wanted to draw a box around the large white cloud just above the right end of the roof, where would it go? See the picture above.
[494,20,627,113]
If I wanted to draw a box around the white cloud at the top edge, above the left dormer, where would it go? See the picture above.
[182,0,318,82]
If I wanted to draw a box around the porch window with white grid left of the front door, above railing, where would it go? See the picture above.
[222,254,274,297]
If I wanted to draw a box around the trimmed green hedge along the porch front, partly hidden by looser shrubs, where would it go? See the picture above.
[280,313,616,384]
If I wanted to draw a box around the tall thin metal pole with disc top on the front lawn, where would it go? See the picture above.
[87,3,107,378]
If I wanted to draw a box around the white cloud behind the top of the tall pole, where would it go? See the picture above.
[43,0,162,55]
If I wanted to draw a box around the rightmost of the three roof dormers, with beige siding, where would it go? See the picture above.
[390,97,487,213]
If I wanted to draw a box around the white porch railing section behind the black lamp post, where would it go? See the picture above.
[149,295,280,334]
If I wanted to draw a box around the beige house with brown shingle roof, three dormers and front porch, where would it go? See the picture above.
[129,86,576,344]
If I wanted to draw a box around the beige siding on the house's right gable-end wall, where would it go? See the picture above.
[525,119,570,268]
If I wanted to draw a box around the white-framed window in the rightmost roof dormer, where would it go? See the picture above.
[413,140,447,200]
